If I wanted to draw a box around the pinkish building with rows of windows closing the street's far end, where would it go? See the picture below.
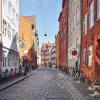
[41,42,52,67]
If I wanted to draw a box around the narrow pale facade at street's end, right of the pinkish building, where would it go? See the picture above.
[51,43,56,67]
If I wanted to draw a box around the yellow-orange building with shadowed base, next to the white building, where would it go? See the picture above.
[19,16,38,69]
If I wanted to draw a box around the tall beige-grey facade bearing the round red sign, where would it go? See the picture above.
[68,0,81,71]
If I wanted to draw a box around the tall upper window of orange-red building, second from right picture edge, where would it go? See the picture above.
[90,0,94,28]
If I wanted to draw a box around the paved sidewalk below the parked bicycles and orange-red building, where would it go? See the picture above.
[57,71,100,100]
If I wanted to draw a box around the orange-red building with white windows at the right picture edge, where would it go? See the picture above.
[80,0,100,85]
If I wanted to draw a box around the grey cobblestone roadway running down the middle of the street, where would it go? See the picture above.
[0,68,97,100]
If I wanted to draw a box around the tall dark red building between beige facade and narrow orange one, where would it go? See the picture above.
[58,0,68,69]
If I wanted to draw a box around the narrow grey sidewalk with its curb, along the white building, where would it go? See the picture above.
[0,70,35,91]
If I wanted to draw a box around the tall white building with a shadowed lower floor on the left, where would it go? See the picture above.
[2,0,19,76]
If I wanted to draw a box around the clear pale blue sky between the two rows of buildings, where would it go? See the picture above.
[20,0,62,47]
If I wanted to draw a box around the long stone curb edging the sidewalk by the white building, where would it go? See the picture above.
[0,72,33,92]
